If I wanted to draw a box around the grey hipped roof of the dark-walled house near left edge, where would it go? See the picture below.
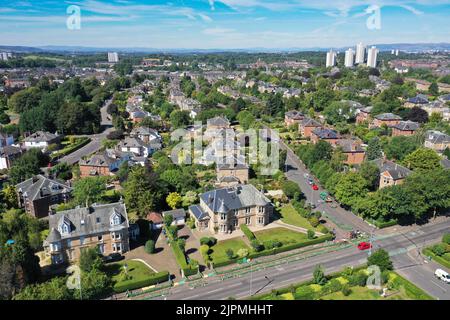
[16,175,72,201]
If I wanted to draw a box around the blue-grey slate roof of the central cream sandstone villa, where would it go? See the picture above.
[200,184,270,213]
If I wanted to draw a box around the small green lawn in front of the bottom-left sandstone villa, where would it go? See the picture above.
[106,260,155,285]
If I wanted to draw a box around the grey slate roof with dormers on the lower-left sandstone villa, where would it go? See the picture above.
[46,202,129,242]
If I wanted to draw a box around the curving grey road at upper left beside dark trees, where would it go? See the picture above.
[58,99,114,165]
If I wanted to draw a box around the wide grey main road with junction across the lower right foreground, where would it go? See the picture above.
[152,219,450,300]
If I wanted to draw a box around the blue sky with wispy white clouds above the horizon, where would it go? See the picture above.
[0,0,450,49]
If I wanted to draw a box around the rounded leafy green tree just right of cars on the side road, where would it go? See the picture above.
[335,172,368,206]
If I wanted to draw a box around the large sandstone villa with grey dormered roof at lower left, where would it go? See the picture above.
[44,202,130,264]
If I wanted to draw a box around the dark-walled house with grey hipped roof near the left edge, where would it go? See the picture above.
[16,175,72,218]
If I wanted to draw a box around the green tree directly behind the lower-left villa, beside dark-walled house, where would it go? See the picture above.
[73,177,106,206]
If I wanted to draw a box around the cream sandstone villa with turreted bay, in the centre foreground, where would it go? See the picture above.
[189,184,273,233]
